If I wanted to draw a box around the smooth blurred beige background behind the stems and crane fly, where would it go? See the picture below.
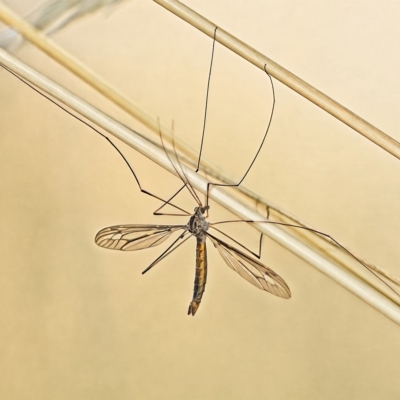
[0,0,400,400]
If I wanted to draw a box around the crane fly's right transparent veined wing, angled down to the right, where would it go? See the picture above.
[207,232,291,299]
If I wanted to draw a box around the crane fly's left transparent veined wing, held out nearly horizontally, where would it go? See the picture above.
[94,225,186,251]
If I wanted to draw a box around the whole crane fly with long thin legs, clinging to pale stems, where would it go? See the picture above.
[0,28,399,316]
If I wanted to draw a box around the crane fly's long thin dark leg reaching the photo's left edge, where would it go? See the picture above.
[0,63,191,216]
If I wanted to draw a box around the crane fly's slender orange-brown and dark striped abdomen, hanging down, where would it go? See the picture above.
[188,234,207,315]
